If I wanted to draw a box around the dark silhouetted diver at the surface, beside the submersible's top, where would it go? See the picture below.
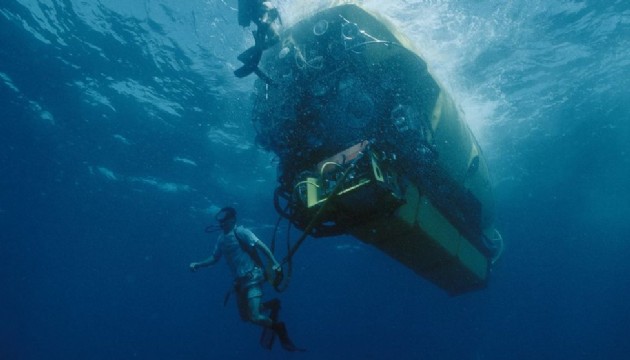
[234,0,282,83]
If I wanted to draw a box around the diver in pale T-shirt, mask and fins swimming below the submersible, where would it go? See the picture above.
[190,207,302,351]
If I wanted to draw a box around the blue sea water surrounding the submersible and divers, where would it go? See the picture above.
[0,0,630,360]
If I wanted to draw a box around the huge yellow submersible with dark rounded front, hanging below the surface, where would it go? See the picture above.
[253,5,502,294]
